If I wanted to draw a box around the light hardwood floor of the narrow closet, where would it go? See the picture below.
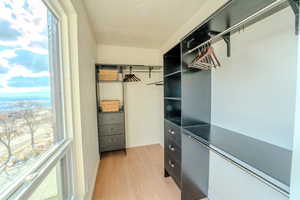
[93,145,180,200]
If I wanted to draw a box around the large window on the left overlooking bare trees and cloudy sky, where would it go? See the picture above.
[0,0,71,200]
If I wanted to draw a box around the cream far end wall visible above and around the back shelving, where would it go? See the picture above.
[97,45,163,147]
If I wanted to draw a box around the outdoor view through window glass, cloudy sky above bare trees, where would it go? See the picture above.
[0,0,59,200]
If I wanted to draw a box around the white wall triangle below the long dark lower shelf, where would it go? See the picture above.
[208,151,288,200]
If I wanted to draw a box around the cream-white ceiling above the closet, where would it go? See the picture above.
[84,0,207,48]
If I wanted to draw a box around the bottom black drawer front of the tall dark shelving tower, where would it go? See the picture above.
[165,154,181,188]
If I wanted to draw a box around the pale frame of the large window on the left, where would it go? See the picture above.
[0,0,74,200]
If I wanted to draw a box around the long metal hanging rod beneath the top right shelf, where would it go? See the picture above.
[183,0,288,56]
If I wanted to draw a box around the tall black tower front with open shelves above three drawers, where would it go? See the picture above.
[164,44,181,188]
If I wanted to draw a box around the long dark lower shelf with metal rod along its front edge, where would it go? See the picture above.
[183,124,292,196]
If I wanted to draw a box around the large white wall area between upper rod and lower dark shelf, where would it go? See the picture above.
[212,8,297,150]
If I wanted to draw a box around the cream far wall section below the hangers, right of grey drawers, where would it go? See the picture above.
[125,72,163,147]
